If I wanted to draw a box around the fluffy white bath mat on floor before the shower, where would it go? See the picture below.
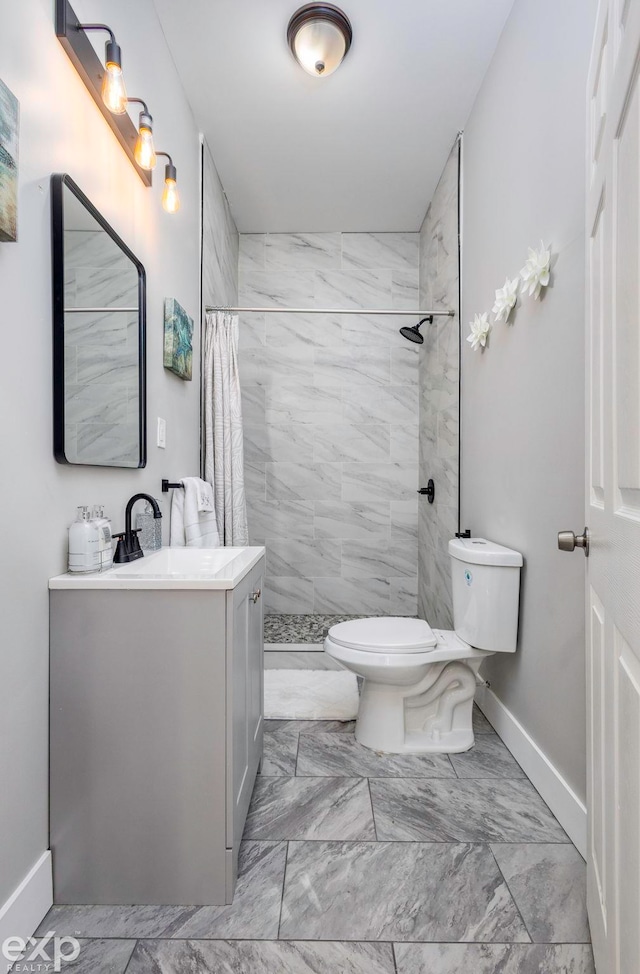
[264,670,359,720]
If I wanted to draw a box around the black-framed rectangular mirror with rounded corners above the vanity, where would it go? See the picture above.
[51,174,147,467]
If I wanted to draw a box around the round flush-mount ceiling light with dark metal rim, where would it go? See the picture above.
[287,3,353,78]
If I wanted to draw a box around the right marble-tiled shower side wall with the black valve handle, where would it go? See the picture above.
[418,144,460,629]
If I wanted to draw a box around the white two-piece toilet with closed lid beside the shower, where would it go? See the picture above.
[324,538,522,754]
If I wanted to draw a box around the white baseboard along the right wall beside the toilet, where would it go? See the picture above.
[476,685,587,858]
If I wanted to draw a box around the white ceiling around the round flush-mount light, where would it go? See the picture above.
[154,0,513,232]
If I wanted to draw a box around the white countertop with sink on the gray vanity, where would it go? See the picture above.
[49,547,264,590]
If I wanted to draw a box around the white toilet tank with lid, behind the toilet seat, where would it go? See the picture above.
[449,538,522,653]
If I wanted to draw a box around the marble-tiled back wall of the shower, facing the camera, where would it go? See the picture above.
[239,233,418,615]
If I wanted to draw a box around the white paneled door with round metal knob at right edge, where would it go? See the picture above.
[588,0,640,974]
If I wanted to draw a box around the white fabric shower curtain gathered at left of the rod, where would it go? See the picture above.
[203,311,249,547]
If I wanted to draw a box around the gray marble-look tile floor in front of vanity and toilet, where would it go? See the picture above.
[36,709,595,974]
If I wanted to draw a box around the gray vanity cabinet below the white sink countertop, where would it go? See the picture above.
[50,557,264,905]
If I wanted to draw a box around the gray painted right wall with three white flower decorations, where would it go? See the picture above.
[461,0,595,797]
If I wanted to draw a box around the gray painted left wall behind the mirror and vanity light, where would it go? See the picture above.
[0,0,235,916]
